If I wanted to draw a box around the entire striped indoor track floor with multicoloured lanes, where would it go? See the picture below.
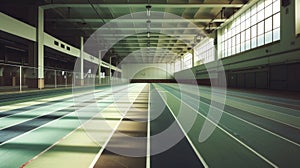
[0,84,300,168]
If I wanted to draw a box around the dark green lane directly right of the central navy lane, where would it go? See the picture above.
[155,85,271,167]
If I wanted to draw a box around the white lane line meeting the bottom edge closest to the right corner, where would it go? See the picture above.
[155,84,278,167]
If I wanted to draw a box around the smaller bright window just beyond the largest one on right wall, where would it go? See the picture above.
[194,38,215,65]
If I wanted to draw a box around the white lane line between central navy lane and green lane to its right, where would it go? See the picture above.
[155,84,209,168]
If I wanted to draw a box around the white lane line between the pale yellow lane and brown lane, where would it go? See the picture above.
[89,85,145,168]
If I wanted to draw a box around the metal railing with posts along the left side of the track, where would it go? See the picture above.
[0,63,128,92]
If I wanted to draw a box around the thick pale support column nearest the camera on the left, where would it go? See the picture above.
[37,7,44,89]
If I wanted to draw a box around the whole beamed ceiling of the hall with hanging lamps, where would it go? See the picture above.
[0,0,248,64]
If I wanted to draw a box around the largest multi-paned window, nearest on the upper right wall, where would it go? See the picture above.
[219,0,280,58]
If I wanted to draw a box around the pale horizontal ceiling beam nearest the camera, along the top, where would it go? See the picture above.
[41,3,244,10]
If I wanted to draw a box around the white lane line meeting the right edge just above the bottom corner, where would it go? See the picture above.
[168,84,300,147]
